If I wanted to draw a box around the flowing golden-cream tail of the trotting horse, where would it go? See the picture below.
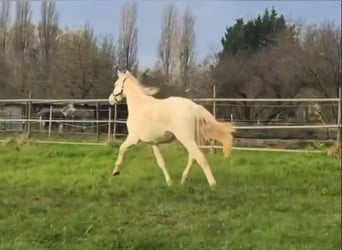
[195,105,235,157]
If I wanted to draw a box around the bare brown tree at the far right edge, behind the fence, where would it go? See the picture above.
[300,22,341,122]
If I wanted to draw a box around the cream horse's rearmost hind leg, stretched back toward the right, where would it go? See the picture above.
[177,137,216,188]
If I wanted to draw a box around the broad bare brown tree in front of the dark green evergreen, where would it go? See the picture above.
[213,31,303,122]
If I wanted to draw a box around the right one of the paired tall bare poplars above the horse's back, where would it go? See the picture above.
[178,8,196,89]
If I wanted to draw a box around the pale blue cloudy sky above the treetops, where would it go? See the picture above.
[18,0,341,68]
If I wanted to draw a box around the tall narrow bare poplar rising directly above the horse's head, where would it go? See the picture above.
[118,3,138,72]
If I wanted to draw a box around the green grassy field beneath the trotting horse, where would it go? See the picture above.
[0,144,341,250]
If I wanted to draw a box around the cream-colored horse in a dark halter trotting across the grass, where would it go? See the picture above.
[109,71,235,187]
